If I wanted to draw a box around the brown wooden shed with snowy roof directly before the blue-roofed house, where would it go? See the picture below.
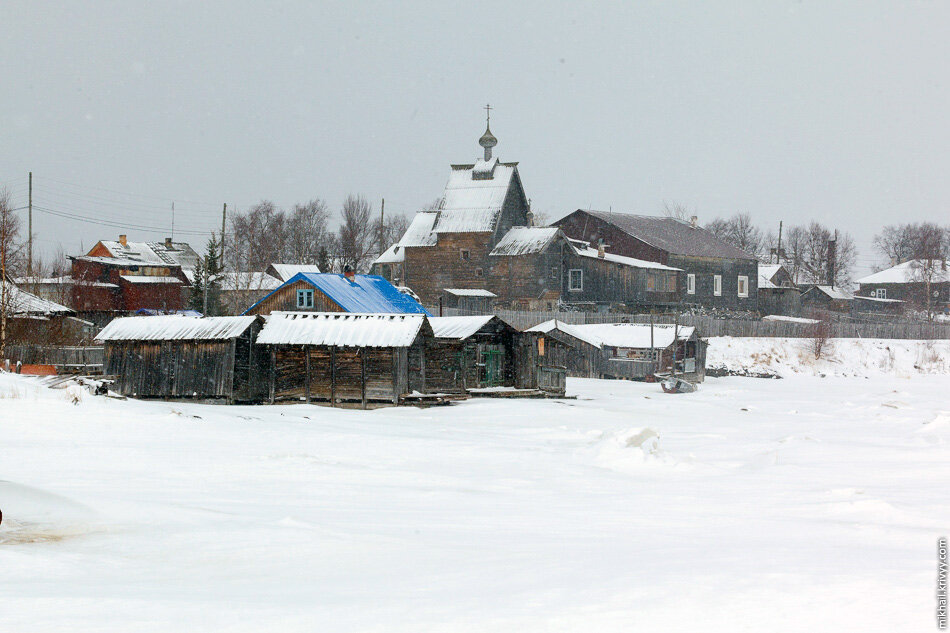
[257,312,432,408]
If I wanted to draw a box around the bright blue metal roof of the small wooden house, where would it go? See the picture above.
[244,273,432,316]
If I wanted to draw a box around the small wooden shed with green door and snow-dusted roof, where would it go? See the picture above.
[425,315,518,393]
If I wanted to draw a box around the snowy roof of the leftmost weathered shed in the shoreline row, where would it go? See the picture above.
[96,314,257,341]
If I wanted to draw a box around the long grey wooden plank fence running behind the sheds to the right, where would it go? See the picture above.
[428,307,950,339]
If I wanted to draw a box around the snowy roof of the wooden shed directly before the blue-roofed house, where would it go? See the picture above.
[257,312,425,347]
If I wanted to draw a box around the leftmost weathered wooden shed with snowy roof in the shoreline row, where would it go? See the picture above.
[96,315,267,403]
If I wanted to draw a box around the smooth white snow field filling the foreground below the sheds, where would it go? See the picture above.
[0,342,950,633]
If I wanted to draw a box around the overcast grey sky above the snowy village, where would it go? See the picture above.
[0,0,950,274]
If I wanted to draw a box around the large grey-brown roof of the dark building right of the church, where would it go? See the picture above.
[558,209,755,259]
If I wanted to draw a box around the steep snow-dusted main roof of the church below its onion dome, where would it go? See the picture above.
[434,161,517,233]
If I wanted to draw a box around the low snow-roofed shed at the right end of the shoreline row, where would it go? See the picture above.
[571,323,707,382]
